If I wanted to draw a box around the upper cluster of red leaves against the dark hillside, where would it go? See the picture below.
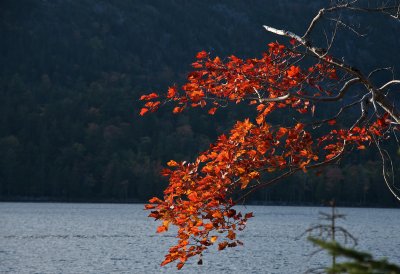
[140,43,336,119]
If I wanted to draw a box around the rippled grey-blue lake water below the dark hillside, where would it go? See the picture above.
[0,203,400,274]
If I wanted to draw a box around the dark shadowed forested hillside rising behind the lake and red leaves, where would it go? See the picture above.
[0,0,400,206]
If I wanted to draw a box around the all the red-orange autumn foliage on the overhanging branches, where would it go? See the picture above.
[140,41,390,269]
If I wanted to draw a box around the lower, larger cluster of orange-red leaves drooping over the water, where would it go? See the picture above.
[146,119,316,268]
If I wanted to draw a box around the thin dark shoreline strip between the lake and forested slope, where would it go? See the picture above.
[0,197,400,208]
